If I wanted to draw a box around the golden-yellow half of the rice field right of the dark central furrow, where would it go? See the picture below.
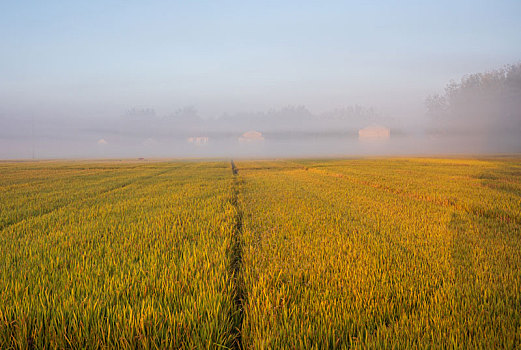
[238,159,521,348]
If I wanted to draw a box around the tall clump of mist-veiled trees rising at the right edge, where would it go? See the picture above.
[425,63,521,132]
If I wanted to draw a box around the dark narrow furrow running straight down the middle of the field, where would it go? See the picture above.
[230,160,245,349]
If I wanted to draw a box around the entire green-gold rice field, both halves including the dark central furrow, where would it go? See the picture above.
[0,157,521,349]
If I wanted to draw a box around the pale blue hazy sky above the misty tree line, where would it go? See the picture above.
[0,0,521,117]
